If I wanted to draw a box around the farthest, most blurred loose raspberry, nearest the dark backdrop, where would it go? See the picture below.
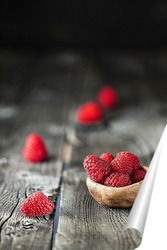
[97,85,118,109]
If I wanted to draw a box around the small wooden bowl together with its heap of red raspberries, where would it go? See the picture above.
[83,151,148,208]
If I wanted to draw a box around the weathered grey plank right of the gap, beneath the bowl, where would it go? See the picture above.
[54,51,166,250]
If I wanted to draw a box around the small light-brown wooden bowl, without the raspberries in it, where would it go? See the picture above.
[86,166,148,208]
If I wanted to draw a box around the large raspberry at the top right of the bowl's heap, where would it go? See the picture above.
[111,151,140,174]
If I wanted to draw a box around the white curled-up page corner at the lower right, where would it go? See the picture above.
[124,126,167,250]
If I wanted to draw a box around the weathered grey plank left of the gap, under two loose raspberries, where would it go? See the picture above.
[0,49,81,250]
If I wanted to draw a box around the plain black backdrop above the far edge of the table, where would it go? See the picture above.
[0,0,167,49]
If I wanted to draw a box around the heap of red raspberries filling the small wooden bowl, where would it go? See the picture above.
[83,151,146,187]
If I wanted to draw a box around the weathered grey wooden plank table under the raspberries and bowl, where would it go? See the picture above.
[0,50,167,250]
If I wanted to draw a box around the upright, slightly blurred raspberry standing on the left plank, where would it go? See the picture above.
[22,134,48,162]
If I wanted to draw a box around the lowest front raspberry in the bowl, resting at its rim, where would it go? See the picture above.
[104,172,131,187]
